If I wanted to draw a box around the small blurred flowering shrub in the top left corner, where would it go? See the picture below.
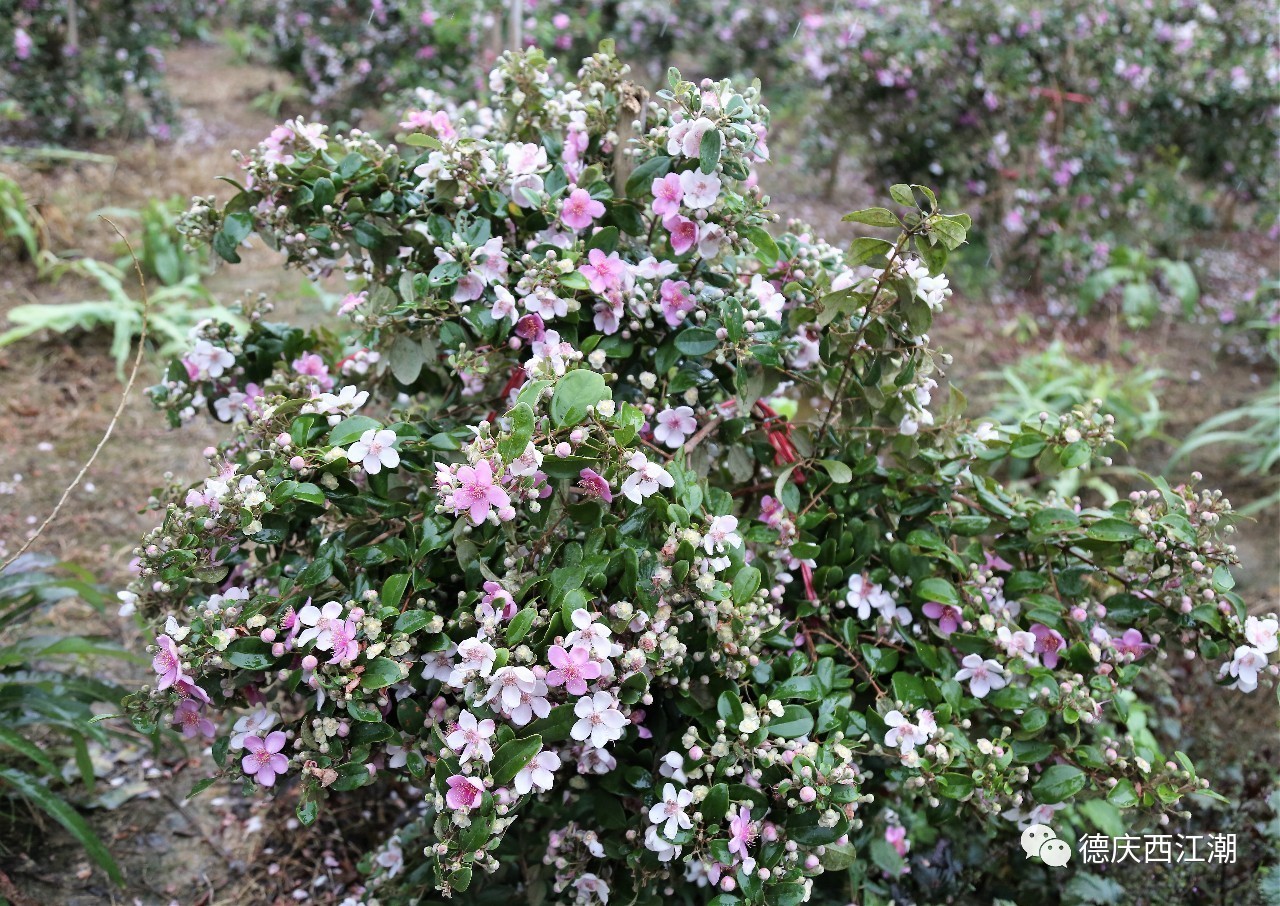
[0,0,186,141]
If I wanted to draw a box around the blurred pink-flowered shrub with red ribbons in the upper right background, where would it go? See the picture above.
[795,0,1280,286]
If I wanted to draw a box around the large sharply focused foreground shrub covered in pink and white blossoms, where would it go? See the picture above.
[122,51,1277,903]
